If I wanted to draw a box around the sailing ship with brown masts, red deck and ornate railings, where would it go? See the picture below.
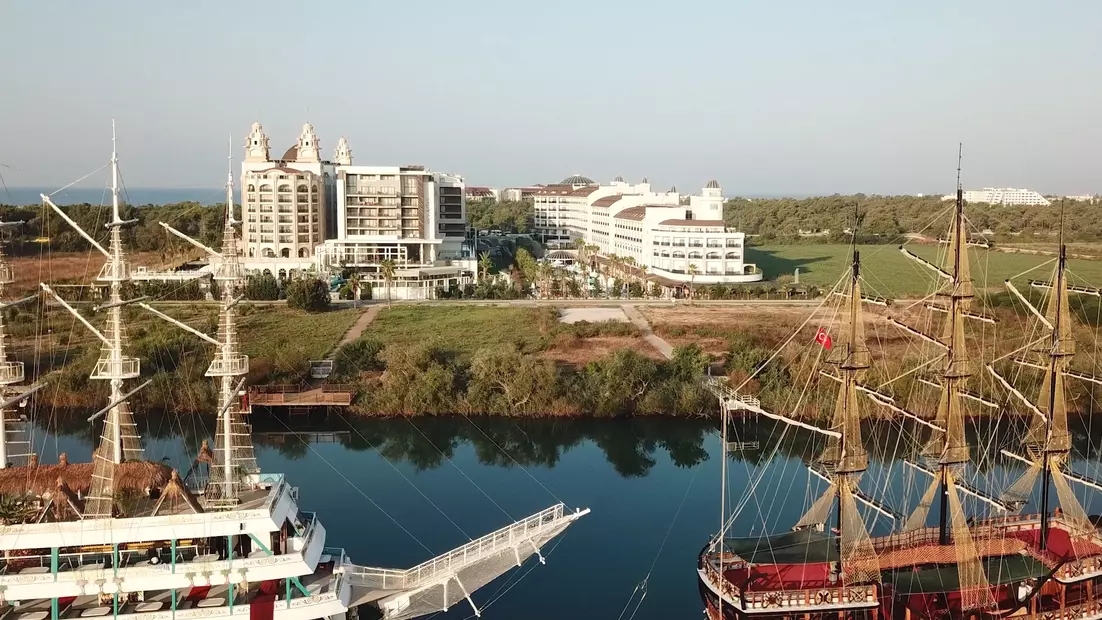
[698,181,1102,620]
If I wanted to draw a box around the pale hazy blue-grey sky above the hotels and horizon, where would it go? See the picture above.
[0,0,1102,195]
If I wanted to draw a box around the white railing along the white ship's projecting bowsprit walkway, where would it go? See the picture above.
[348,503,565,589]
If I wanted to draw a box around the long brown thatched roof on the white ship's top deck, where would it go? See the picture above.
[0,455,172,497]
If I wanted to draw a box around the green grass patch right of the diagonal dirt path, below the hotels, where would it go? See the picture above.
[364,306,553,355]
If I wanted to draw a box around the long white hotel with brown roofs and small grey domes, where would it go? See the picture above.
[533,175,761,285]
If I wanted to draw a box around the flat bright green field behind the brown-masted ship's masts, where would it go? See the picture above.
[746,243,1102,297]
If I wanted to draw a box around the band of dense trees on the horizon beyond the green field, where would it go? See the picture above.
[724,194,1102,243]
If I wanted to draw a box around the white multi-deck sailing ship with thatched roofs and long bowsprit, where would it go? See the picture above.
[0,123,588,620]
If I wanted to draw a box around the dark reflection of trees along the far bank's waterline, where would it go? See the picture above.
[44,412,1102,478]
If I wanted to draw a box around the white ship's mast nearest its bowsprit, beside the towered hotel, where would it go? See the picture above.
[141,138,259,509]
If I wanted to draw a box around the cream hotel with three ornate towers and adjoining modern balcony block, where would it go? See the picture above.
[241,123,471,298]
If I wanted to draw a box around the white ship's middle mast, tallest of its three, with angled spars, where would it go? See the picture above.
[42,121,143,519]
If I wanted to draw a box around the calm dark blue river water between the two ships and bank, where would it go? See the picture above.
[27,416,1102,620]
